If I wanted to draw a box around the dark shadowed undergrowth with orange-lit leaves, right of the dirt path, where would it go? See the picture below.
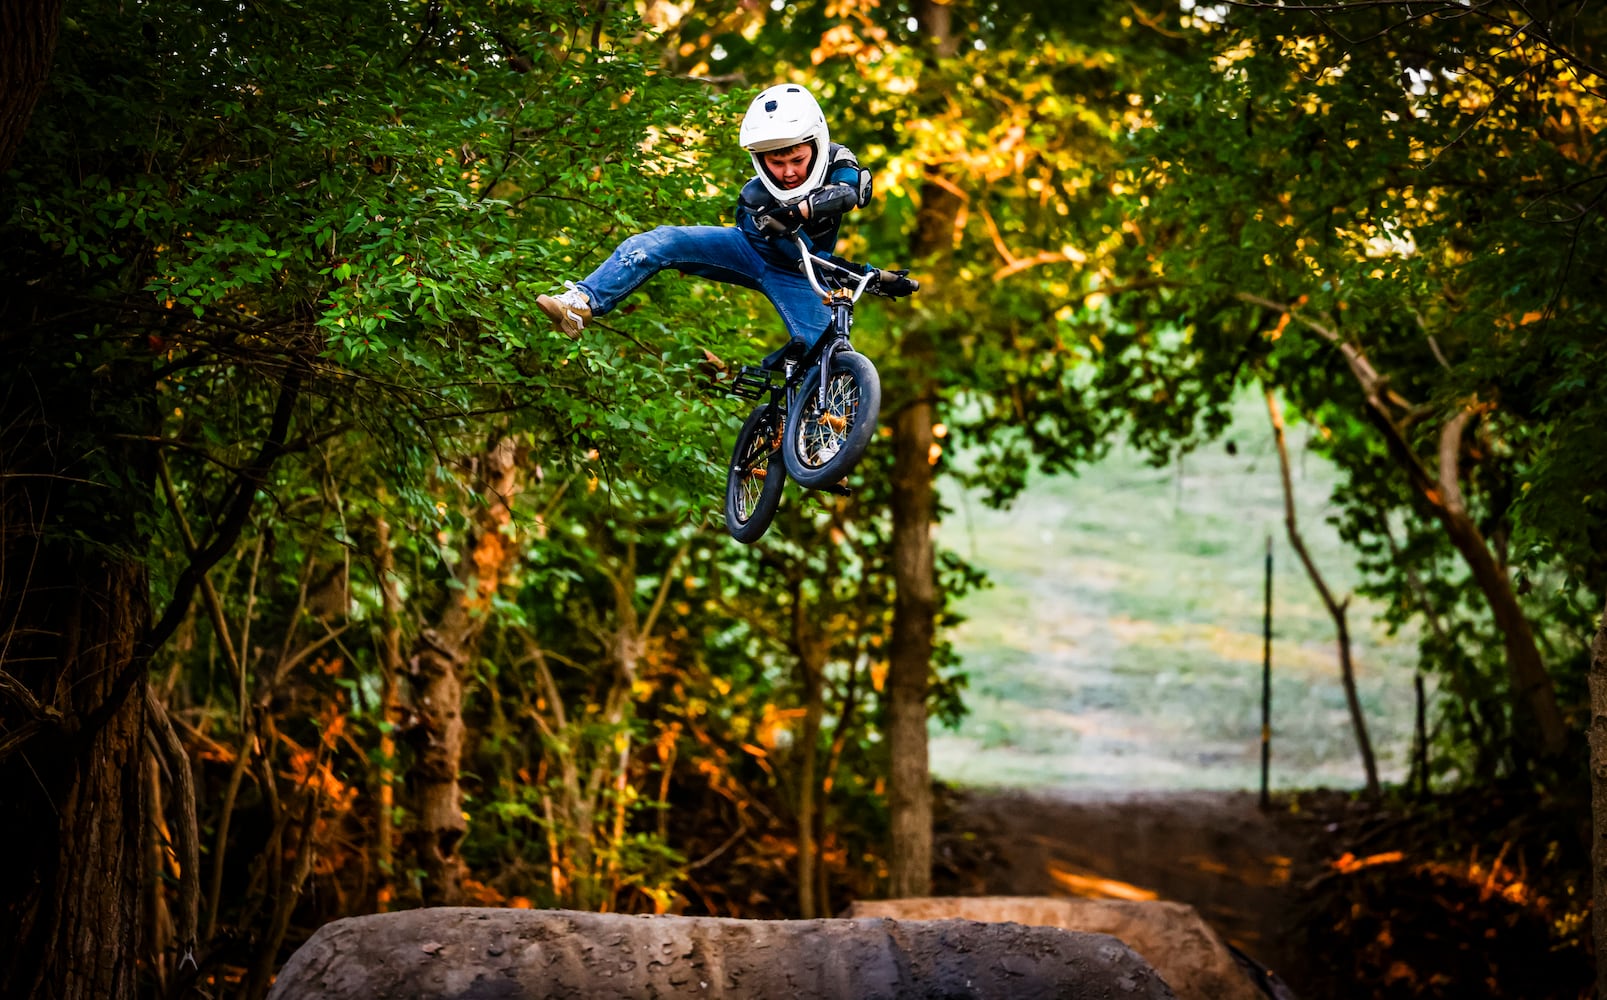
[1289,786,1593,1000]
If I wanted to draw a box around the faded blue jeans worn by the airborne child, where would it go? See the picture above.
[579,225,831,347]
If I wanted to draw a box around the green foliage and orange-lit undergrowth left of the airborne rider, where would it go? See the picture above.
[0,2,932,995]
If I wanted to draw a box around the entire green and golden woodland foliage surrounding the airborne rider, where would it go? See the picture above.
[9,0,1607,995]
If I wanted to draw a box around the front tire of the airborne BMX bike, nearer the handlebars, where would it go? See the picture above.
[781,350,882,489]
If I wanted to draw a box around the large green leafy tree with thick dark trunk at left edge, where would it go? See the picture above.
[0,3,736,997]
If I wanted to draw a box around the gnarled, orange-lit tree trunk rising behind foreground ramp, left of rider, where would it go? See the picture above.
[408,439,519,905]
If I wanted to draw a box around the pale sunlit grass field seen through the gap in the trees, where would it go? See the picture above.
[932,397,1414,789]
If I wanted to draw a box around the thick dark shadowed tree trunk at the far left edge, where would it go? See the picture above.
[0,321,156,1000]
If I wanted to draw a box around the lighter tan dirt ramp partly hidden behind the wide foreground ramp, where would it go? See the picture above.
[847,895,1266,1000]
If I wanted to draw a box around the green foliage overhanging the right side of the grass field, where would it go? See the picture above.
[1107,5,1607,775]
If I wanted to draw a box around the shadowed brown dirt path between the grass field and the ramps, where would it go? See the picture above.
[934,791,1306,990]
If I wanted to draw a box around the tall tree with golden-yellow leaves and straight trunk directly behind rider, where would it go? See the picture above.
[652,0,1178,895]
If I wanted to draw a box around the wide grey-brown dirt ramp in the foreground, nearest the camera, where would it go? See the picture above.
[268,907,1173,1000]
